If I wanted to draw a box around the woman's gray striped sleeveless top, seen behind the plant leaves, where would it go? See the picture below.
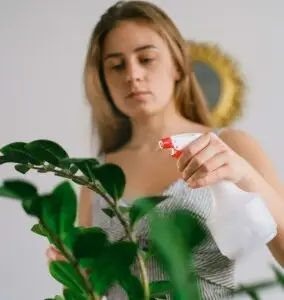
[92,131,235,300]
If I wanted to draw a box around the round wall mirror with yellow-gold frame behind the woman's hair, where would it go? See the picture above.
[188,41,245,127]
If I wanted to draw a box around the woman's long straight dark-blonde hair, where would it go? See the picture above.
[84,1,211,153]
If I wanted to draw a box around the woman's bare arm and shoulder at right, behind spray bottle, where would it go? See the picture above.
[220,130,284,267]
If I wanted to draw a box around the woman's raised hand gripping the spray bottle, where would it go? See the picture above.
[177,133,252,188]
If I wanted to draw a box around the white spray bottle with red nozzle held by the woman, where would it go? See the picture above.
[159,133,277,260]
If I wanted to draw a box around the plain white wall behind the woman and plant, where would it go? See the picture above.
[0,0,284,300]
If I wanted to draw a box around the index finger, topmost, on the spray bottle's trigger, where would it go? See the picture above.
[177,133,212,172]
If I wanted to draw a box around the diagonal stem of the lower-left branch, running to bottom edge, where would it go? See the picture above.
[40,220,100,300]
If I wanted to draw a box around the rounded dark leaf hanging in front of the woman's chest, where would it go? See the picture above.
[94,163,126,201]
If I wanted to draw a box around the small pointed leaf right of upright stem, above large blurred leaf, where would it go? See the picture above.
[129,196,168,226]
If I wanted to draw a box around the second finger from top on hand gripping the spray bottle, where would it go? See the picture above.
[182,144,225,180]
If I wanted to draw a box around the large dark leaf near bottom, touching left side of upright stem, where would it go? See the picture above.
[90,241,137,296]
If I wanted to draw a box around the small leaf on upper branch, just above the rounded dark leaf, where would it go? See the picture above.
[61,158,99,181]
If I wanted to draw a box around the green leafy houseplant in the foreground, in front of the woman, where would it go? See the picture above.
[0,140,284,300]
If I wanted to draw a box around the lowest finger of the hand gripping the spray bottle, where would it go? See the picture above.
[188,164,229,188]
